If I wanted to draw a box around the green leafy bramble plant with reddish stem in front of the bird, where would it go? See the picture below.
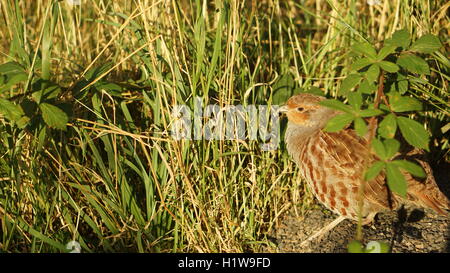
[321,30,442,249]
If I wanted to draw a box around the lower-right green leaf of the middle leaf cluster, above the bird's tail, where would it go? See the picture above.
[397,117,430,151]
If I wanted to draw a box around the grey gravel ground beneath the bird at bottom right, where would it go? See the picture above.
[264,203,450,253]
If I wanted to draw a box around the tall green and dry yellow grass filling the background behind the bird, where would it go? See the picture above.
[0,0,450,252]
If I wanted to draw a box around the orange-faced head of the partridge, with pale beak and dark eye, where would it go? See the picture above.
[279,93,337,129]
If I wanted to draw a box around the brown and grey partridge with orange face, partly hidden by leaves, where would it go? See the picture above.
[279,93,450,245]
